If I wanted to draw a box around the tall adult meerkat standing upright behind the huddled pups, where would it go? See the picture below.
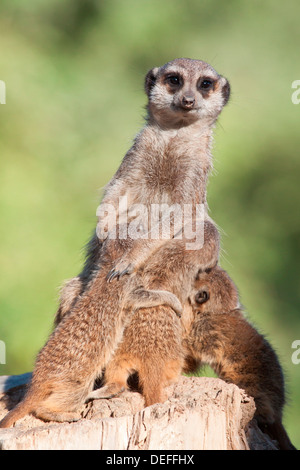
[55,58,230,325]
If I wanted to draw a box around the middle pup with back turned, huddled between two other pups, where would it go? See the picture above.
[88,222,219,406]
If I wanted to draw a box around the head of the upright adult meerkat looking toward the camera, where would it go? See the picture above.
[145,59,230,127]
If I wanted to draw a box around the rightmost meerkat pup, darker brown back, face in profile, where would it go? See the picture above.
[183,266,295,450]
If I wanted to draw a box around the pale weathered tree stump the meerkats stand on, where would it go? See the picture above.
[0,374,277,450]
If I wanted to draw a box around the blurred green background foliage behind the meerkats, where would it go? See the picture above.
[0,0,300,447]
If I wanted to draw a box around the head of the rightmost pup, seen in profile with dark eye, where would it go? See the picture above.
[189,266,240,313]
